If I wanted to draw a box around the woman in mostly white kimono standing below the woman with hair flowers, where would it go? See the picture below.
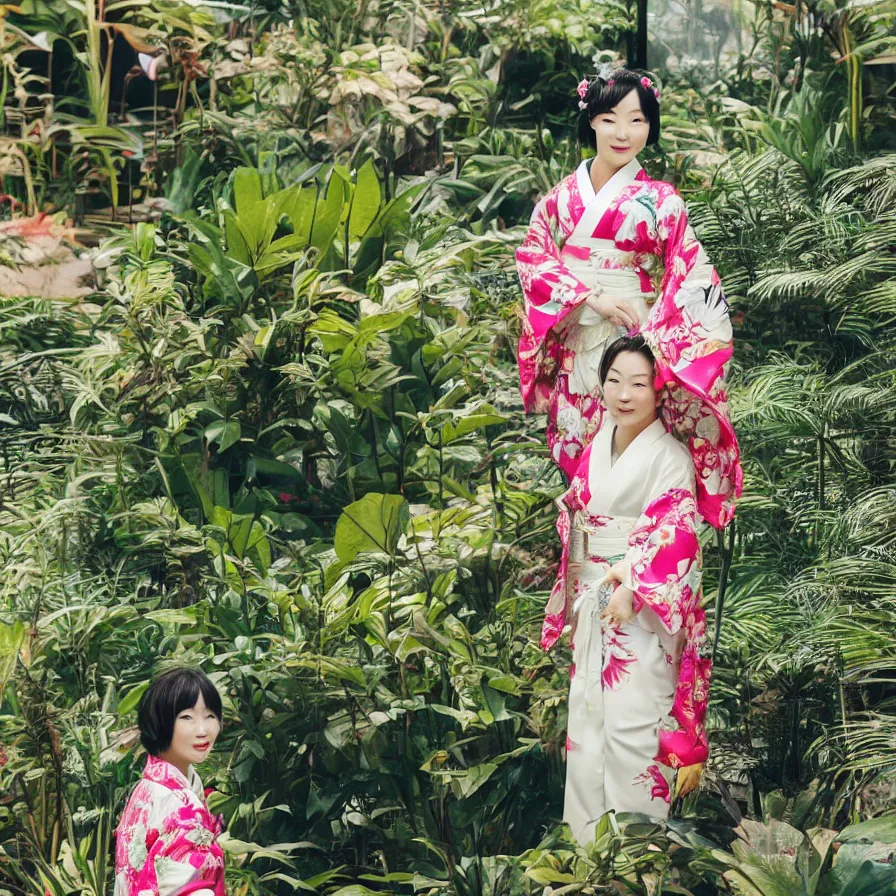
[542,336,711,843]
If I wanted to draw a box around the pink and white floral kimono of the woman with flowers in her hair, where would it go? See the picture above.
[516,159,741,526]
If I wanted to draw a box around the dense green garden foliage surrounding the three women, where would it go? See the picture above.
[0,0,896,896]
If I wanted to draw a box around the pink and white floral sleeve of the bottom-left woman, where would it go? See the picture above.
[151,804,224,896]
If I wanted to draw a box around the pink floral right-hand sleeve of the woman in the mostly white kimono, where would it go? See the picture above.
[626,488,712,768]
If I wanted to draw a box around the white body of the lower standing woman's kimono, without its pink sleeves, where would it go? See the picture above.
[563,420,702,843]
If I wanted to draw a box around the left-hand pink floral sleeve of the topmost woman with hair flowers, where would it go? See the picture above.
[516,186,593,413]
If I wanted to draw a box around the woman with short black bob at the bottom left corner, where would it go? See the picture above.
[114,668,224,896]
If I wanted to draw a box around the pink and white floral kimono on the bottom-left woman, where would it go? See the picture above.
[114,756,224,896]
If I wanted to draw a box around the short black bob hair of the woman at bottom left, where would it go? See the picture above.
[137,666,222,756]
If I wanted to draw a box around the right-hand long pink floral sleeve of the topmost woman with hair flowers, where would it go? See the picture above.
[643,183,743,528]
